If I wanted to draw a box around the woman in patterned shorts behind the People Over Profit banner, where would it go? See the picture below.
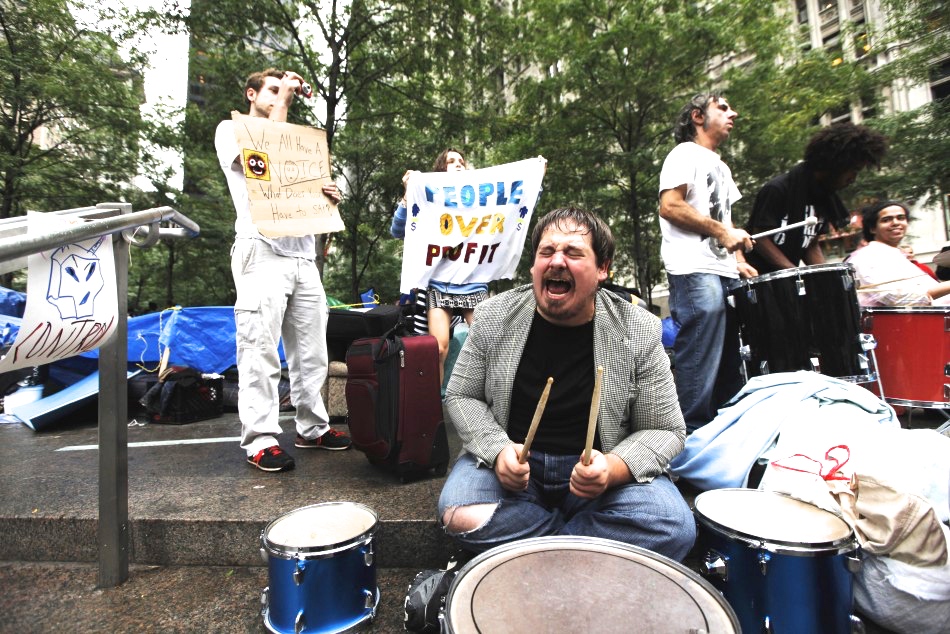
[389,148,488,384]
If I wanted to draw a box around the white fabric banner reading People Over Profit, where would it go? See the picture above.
[400,156,546,293]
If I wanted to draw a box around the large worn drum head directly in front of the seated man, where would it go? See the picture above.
[446,537,739,634]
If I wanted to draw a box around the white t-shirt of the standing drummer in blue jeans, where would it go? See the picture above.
[660,142,742,278]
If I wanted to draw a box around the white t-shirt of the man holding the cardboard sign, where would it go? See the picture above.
[214,119,316,260]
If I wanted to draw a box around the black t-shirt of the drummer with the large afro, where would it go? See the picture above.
[746,163,848,274]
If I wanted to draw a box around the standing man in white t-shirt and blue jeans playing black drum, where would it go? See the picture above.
[660,94,758,431]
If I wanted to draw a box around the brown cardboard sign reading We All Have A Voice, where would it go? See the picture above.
[231,111,343,238]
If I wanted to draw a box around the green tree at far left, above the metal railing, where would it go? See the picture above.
[0,0,143,218]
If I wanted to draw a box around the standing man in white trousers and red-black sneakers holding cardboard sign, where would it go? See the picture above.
[214,69,350,471]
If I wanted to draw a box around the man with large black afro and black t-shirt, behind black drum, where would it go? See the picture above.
[746,123,887,274]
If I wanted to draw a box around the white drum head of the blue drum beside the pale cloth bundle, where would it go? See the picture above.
[695,489,851,544]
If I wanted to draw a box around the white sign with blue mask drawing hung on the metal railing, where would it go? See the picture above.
[0,212,119,372]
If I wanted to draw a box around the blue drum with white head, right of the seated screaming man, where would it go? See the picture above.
[694,489,861,634]
